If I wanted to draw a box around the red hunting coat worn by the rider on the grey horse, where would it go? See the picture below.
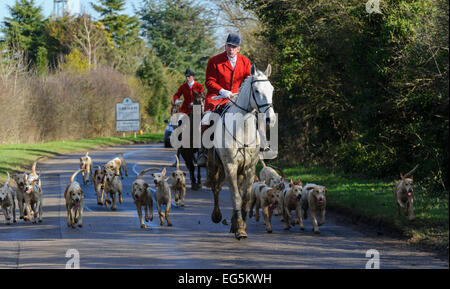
[205,51,251,111]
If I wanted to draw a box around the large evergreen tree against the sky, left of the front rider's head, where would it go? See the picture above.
[139,0,215,81]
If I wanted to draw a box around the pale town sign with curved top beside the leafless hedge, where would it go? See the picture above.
[116,97,141,132]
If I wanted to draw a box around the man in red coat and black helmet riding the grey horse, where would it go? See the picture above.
[197,33,251,166]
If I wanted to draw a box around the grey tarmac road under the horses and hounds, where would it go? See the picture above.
[0,143,449,269]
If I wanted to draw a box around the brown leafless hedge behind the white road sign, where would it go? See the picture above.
[0,68,145,143]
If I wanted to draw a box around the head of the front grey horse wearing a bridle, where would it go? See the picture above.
[250,64,276,128]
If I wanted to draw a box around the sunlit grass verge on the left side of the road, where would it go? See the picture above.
[0,133,164,183]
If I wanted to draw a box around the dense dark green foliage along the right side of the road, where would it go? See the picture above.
[244,0,449,196]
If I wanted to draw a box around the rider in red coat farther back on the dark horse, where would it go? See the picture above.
[173,68,204,114]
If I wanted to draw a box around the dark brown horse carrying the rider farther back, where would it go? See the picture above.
[179,90,205,190]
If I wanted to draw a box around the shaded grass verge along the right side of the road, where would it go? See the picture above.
[257,162,449,255]
